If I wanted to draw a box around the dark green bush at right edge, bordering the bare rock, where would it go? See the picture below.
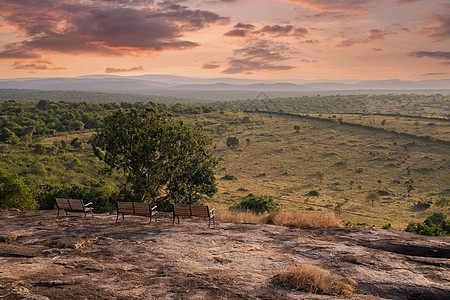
[405,213,450,236]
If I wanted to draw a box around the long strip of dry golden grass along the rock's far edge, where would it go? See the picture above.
[269,211,342,228]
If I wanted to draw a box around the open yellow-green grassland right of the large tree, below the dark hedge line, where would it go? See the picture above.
[182,112,450,229]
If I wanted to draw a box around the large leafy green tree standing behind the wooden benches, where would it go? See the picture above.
[90,109,217,203]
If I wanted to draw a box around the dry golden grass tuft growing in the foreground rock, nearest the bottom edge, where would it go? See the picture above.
[277,264,357,296]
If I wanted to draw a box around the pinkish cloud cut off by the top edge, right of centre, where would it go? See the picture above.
[285,0,379,14]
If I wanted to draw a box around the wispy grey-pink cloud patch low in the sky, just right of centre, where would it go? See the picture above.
[222,40,294,74]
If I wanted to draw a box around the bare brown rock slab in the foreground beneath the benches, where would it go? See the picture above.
[0,211,450,300]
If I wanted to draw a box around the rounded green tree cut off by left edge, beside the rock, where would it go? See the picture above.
[0,169,34,210]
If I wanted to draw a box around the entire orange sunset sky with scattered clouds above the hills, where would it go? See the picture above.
[0,0,450,81]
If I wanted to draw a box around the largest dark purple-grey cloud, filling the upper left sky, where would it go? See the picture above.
[0,0,229,59]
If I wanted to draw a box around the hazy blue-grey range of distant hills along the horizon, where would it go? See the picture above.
[0,74,450,95]
